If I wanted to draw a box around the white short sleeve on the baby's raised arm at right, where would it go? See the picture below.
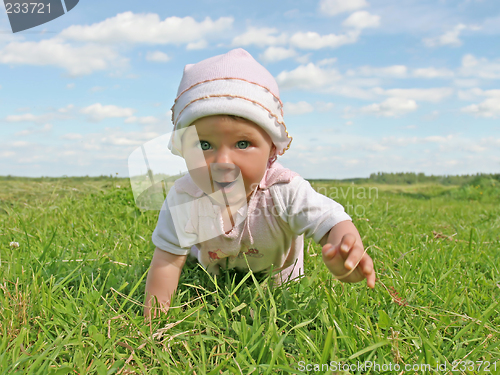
[269,176,352,243]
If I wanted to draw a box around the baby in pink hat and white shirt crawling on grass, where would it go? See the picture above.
[145,49,375,316]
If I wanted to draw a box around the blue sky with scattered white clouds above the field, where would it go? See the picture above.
[0,0,500,178]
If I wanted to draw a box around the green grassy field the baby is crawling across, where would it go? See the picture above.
[0,178,500,374]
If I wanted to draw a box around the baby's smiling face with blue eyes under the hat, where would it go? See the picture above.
[182,115,273,205]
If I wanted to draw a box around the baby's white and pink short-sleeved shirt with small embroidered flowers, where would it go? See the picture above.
[152,162,351,280]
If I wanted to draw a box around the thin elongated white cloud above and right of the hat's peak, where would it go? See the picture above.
[290,30,360,50]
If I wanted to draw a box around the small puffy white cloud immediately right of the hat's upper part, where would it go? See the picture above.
[276,63,341,90]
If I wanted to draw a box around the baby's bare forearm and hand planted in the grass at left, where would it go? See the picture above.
[144,247,187,318]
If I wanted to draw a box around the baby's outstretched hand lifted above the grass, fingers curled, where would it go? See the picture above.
[322,233,375,289]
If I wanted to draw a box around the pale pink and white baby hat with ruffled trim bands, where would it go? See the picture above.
[168,48,292,155]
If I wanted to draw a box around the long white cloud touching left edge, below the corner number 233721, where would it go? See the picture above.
[0,38,128,76]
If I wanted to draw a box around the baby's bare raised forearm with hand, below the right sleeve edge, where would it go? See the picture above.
[320,220,375,288]
